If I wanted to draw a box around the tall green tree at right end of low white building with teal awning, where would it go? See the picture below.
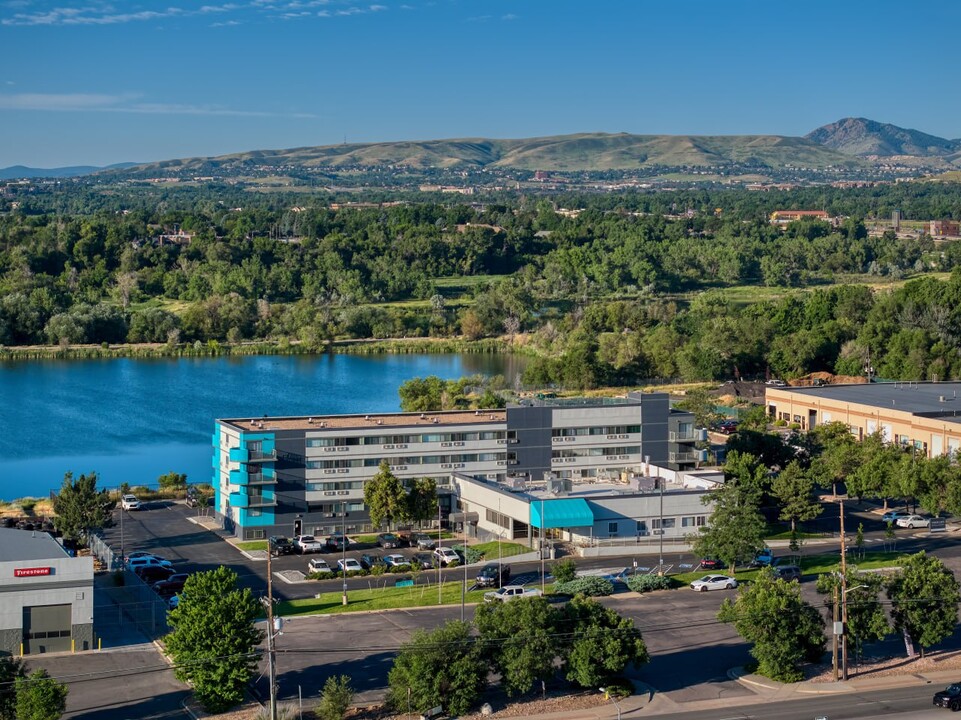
[691,452,765,573]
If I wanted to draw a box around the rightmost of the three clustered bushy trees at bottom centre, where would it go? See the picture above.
[560,596,650,688]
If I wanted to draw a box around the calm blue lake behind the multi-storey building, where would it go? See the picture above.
[0,355,522,500]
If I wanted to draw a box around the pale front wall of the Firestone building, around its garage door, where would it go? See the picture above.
[0,557,93,655]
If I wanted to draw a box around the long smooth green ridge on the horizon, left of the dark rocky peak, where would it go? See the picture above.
[118,133,862,173]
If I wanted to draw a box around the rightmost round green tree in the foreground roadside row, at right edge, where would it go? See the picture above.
[888,551,961,657]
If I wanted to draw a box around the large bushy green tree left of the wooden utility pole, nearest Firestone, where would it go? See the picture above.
[164,566,264,712]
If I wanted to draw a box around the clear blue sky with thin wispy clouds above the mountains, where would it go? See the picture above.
[0,0,961,167]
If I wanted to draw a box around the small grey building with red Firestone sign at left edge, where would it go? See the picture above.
[0,528,93,655]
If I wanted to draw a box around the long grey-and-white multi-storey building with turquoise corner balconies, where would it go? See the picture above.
[212,393,701,539]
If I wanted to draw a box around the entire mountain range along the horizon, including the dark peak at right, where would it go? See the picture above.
[0,118,961,179]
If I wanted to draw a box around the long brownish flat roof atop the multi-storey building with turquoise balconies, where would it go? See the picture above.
[218,410,507,432]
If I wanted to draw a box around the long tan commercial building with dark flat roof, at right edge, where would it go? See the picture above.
[765,382,961,457]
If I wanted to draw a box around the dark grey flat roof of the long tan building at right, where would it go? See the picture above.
[769,382,961,416]
